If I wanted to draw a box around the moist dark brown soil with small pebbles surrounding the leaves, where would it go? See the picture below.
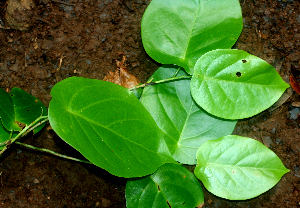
[0,0,300,208]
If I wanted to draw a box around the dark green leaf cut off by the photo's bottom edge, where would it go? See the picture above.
[125,164,204,208]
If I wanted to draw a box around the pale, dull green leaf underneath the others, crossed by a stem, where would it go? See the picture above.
[141,65,236,165]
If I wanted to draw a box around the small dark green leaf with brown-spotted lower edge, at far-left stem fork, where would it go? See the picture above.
[9,87,47,134]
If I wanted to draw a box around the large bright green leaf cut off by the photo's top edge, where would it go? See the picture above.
[141,0,243,74]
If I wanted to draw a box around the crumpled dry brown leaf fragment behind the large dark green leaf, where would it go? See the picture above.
[103,53,140,88]
